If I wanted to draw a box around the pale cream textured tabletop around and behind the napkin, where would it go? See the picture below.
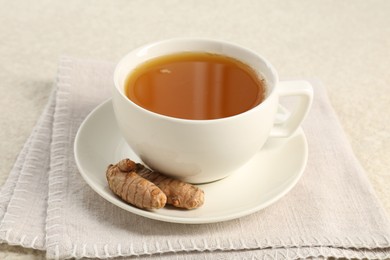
[0,0,390,259]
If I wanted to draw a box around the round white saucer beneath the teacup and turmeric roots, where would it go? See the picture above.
[74,100,308,224]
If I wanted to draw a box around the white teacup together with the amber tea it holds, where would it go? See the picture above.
[112,39,313,183]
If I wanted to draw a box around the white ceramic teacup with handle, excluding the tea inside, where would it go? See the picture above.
[112,38,313,183]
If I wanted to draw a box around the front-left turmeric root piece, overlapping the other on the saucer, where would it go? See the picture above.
[106,164,167,209]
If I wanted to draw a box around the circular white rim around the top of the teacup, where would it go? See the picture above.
[113,37,279,124]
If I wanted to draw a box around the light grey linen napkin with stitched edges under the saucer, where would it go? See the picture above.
[0,58,390,259]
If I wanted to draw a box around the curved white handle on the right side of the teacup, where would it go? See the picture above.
[270,80,313,137]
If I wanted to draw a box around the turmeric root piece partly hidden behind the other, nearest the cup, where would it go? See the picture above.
[118,159,204,209]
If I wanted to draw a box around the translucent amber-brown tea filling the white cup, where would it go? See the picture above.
[125,52,265,120]
